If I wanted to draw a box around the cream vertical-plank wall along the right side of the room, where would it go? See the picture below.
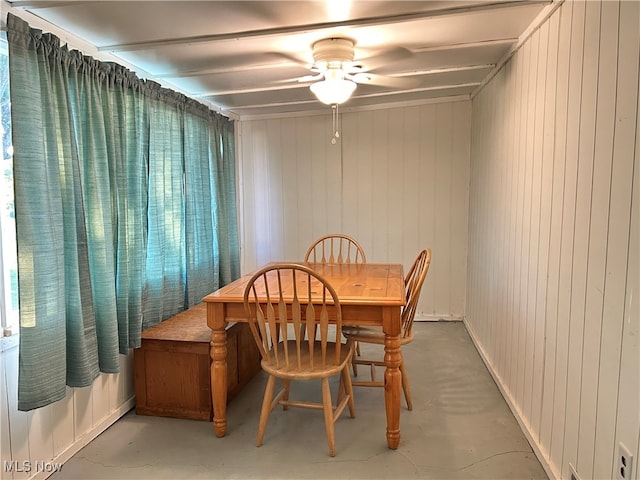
[466,1,640,479]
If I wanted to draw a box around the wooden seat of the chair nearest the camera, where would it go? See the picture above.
[262,340,353,380]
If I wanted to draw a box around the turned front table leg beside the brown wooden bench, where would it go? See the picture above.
[207,303,227,437]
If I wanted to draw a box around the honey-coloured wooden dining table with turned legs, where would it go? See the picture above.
[204,263,405,449]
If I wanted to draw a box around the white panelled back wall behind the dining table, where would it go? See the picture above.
[238,101,471,319]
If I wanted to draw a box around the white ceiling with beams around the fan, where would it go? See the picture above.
[3,0,553,118]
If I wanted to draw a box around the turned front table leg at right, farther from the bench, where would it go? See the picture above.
[384,334,402,450]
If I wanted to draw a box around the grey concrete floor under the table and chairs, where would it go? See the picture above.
[50,322,548,480]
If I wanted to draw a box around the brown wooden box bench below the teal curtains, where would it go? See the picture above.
[133,302,260,421]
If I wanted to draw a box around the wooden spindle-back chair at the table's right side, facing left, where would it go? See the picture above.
[342,248,431,410]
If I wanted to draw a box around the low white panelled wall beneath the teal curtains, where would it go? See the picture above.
[0,346,135,480]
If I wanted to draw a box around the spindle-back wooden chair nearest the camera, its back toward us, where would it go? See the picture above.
[244,263,355,457]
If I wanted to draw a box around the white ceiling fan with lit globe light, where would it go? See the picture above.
[288,37,416,105]
